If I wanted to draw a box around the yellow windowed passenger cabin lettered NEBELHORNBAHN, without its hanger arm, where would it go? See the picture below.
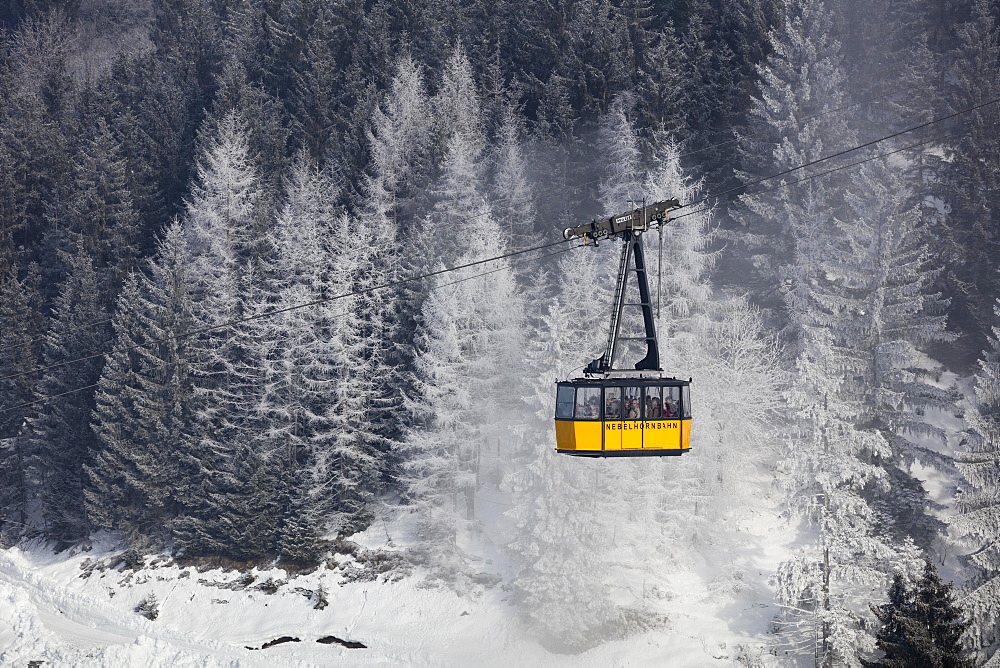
[556,378,691,457]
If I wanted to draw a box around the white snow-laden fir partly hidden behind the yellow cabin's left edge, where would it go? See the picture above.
[506,290,619,651]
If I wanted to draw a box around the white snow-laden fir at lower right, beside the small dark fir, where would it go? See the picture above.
[773,328,916,666]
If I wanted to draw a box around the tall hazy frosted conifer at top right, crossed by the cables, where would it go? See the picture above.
[721,0,853,328]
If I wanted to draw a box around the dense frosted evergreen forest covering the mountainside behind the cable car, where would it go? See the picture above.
[0,0,1000,666]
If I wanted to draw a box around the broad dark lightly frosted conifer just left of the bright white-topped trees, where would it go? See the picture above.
[87,222,201,551]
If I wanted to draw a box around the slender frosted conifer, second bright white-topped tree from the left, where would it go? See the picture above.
[251,154,340,563]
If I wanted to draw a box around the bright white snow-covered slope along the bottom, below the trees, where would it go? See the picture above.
[0,506,794,667]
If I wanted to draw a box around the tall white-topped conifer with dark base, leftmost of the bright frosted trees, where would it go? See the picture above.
[174,113,277,558]
